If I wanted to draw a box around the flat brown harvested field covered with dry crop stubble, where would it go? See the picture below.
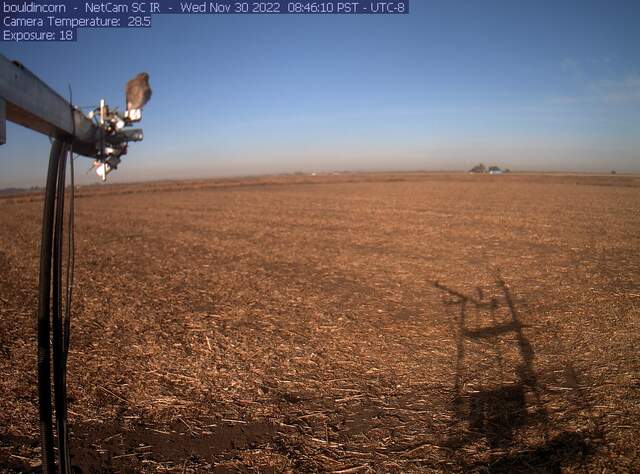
[0,174,640,474]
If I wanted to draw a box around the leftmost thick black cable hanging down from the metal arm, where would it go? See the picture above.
[37,139,64,474]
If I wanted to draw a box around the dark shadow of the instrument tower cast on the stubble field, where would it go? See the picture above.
[434,277,588,472]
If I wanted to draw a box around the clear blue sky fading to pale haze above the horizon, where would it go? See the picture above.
[0,0,640,187]
